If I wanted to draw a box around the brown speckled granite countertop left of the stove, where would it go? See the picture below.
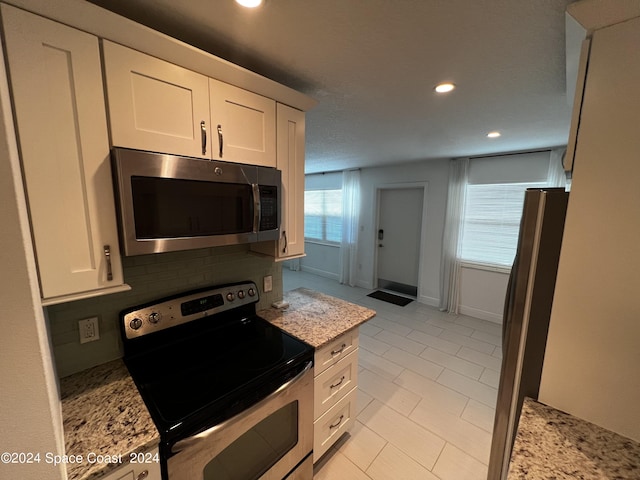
[60,360,160,480]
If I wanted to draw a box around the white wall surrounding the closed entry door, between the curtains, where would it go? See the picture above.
[357,160,449,306]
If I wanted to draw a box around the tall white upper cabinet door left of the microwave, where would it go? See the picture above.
[2,4,123,303]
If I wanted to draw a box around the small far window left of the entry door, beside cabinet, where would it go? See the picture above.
[304,190,342,243]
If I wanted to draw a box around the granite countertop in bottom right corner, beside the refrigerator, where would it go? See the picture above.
[507,398,640,480]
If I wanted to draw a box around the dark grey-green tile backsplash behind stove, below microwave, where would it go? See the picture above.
[45,245,282,377]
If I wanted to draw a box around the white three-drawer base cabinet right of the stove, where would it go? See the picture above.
[313,329,358,463]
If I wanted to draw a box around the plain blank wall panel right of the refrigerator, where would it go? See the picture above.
[540,18,640,441]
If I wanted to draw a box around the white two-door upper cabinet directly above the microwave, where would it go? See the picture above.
[103,40,276,167]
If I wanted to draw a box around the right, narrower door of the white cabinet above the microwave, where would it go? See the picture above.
[209,79,276,167]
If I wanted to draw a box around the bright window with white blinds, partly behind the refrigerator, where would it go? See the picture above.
[459,182,547,267]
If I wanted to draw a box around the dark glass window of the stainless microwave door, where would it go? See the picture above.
[131,176,253,239]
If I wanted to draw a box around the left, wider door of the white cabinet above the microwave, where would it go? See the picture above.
[103,40,211,158]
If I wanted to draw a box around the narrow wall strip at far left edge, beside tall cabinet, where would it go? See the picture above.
[0,50,66,480]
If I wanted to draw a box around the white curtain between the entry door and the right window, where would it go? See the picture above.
[440,158,469,313]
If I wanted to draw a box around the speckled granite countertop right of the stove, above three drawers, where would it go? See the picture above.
[258,288,376,349]
